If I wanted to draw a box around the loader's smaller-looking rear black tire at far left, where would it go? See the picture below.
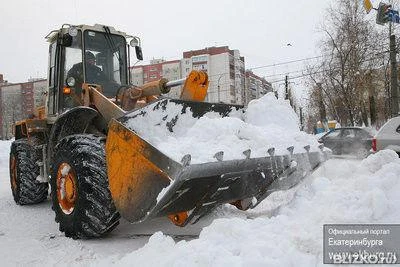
[9,137,49,205]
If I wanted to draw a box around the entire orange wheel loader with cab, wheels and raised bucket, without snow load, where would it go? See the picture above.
[10,24,325,238]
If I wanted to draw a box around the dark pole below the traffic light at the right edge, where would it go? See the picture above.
[390,34,399,117]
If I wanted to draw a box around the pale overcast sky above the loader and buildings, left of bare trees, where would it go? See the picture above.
[0,0,331,85]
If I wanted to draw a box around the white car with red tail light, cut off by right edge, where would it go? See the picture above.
[372,116,400,155]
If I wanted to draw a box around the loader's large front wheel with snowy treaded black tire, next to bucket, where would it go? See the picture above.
[50,134,120,238]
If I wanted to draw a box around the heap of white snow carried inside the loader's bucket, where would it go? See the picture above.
[126,93,318,163]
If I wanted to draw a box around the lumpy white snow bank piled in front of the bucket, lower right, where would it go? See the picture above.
[95,151,400,266]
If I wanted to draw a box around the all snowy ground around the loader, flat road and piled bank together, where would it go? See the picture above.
[0,137,400,266]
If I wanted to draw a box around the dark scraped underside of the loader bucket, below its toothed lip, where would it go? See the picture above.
[153,152,321,226]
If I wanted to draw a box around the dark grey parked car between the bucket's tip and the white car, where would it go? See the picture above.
[318,127,373,158]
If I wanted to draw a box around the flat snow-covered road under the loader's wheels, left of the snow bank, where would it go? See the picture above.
[0,138,209,266]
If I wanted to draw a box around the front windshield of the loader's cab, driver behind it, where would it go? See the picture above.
[84,31,128,97]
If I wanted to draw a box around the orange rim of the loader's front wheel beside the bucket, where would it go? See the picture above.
[57,162,78,214]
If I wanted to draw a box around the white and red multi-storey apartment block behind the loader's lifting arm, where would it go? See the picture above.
[130,46,272,105]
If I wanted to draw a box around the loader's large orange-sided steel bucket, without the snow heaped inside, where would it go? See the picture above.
[106,99,324,226]
